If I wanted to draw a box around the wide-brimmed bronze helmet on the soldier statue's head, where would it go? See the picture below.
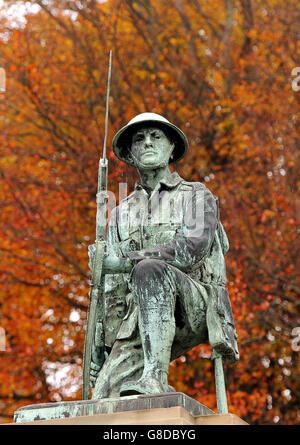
[112,113,188,165]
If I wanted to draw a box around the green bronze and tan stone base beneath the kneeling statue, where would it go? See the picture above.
[14,392,247,425]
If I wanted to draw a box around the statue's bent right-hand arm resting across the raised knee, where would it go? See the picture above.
[127,186,218,271]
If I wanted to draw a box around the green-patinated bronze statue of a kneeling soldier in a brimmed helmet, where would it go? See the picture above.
[89,113,239,399]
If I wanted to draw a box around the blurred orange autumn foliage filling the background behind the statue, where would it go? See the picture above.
[0,0,300,424]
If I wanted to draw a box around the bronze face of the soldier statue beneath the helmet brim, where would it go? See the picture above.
[131,127,174,168]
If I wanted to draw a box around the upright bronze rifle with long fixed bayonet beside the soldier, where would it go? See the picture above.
[82,51,112,400]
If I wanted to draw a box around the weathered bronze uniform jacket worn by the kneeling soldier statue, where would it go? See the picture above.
[91,172,238,362]
